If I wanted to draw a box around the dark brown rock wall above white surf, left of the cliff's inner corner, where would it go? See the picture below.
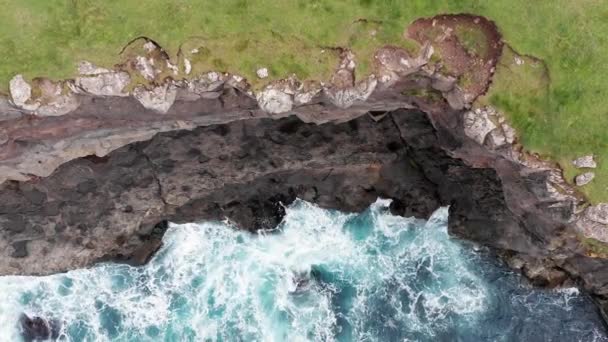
[0,112,440,274]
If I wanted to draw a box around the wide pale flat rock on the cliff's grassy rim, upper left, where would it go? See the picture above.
[72,71,131,96]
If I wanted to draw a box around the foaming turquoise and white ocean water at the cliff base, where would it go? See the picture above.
[0,200,608,341]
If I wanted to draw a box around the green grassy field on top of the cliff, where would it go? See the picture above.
[0,0,608,202]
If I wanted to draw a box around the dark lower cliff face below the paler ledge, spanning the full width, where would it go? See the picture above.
[0,107,608,320]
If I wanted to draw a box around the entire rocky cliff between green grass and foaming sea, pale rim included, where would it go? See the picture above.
[0,17,608,324]
